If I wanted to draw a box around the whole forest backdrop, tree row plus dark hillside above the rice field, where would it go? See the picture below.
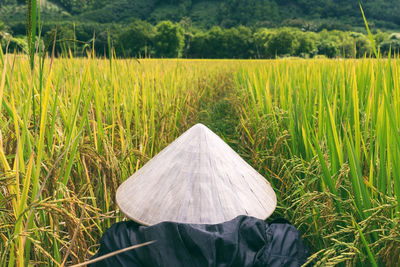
[0,0,400,58]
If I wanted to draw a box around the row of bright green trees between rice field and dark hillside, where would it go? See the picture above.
[0,20,400,59]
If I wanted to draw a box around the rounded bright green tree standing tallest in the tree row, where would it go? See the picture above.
[154,21,184,58]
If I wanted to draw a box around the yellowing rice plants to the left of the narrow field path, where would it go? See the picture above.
[0,54,241,266]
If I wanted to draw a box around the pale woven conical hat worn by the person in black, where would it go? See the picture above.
[116,124,276,225]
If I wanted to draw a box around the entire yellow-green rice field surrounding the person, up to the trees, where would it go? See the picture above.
[0,54,400,266]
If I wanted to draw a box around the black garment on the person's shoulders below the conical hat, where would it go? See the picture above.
[90,216,308,267]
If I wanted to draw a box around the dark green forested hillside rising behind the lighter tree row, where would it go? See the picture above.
[0,0,400,30]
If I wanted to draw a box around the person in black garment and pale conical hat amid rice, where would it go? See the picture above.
[88,124,309,267]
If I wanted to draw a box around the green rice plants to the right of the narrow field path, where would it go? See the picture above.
[235,58,400,265]
